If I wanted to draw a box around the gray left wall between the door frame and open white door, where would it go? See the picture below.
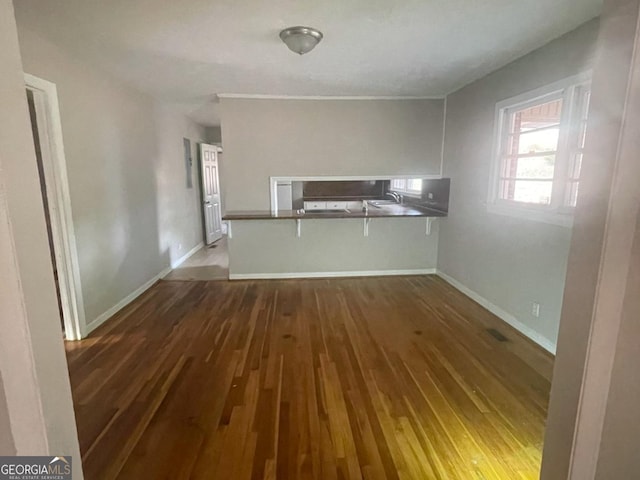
[17,24,205,324]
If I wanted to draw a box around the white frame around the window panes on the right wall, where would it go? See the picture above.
[487,71,591,227]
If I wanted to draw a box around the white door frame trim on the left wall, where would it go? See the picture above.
[24,73,86,340]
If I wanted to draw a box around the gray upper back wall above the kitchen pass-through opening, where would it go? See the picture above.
[220,98,444,210]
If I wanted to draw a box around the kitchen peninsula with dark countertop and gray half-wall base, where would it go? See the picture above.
[223,179,449,280]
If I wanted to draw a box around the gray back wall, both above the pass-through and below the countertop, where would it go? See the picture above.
[220,98,444,275]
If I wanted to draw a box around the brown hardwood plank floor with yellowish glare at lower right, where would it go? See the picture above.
[66,276,553,480]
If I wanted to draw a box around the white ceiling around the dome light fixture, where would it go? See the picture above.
[14,0,602,125]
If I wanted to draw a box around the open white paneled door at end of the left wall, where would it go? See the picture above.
[200,143,222,245]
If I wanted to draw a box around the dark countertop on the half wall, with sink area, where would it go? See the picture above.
[222,205,447,220]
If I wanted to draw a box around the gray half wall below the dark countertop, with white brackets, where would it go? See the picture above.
[229,218,438,275]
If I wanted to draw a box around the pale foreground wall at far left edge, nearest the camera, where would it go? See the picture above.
[0,0,82,472]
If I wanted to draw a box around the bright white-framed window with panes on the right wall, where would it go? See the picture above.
[489,77,590,224]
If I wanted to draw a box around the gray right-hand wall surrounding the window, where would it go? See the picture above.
[438,21,598,344]
